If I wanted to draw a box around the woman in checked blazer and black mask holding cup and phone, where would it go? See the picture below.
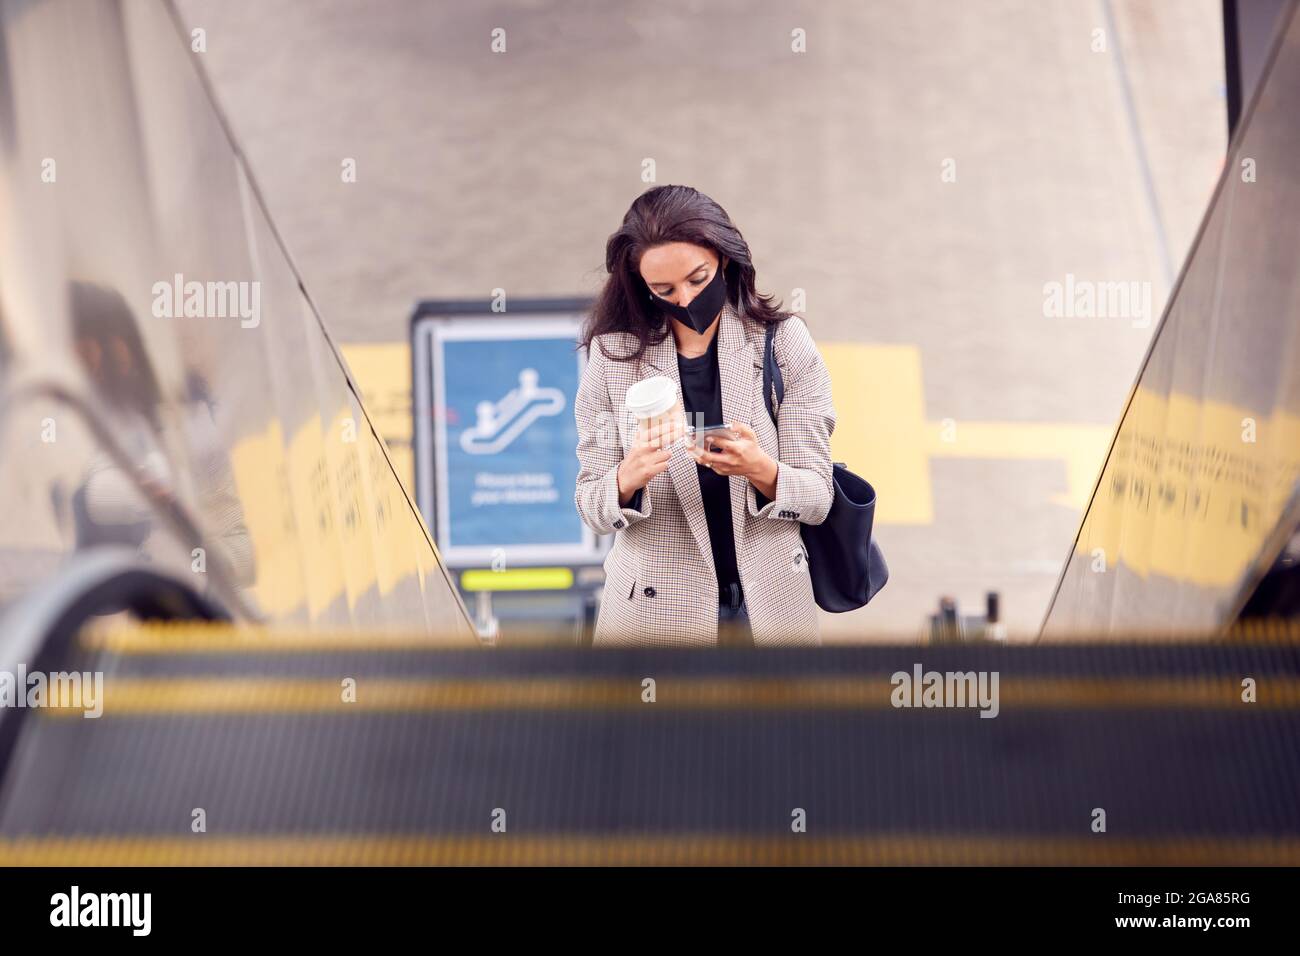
[575,186,836,646]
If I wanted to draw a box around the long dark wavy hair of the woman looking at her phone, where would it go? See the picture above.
[580,186,787,362]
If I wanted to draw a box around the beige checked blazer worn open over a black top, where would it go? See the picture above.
[573,302,836,646]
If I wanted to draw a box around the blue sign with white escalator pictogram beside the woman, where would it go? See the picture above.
[416,315,599,567]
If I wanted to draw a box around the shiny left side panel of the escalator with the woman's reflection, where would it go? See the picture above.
[0,0,477,645]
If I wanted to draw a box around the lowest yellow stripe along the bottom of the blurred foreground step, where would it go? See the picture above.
[0,832,1300,866]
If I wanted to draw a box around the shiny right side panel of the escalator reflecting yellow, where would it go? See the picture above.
[1043,3,1300,639]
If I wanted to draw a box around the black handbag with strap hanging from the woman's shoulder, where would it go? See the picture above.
[763,323,889,614]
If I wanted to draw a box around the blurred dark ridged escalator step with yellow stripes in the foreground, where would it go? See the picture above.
[0,626,1300,865]
